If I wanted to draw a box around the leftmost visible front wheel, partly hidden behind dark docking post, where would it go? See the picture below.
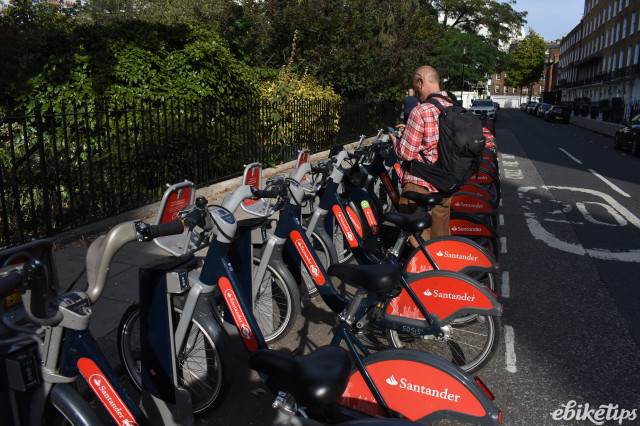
[118,304,235,414]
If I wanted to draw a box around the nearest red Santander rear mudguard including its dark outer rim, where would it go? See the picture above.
[338,349,500,425]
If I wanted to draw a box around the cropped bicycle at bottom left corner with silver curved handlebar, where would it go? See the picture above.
[0,222,193,426]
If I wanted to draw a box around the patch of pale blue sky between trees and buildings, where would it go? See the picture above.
[511,0,584,41]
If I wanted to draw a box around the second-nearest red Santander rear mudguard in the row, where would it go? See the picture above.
[385,271,502,326]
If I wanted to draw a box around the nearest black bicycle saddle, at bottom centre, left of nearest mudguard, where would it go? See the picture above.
[249,345,351,410]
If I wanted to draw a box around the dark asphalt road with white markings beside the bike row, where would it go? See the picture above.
[481,110,640,425]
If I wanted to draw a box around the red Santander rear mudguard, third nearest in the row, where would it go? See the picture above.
[404,236,499,274]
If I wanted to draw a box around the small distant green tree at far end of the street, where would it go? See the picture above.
[505,30,547,99]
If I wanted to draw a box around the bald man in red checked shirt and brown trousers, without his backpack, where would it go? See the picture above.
[394,65,451,247]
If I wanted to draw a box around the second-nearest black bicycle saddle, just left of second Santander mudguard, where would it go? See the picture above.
[327,263,402,293]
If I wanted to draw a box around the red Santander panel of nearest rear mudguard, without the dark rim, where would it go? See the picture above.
[338,360,486,420]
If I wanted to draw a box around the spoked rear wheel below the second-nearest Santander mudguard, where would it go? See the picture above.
[386,315,502,373]
